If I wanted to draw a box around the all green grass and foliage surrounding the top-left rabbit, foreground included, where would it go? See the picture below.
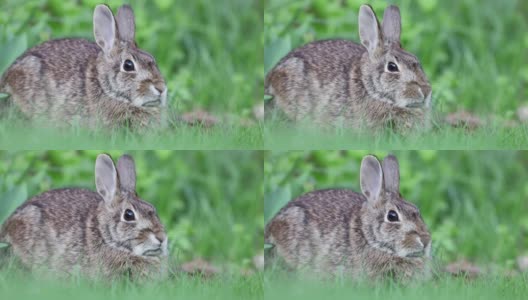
[0,0,264,149]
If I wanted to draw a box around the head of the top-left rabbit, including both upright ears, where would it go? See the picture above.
[93,5,167,107]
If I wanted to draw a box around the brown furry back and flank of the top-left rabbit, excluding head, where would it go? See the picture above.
[3,39,100,120]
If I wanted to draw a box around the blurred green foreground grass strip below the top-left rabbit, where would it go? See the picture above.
[0,122,262,150]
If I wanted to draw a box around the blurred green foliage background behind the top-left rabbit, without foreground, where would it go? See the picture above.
[0,0,263,117]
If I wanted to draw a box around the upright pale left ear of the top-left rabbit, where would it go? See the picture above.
[93,4,116,53]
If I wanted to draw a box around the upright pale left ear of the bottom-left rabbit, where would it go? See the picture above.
[95,154,117,203]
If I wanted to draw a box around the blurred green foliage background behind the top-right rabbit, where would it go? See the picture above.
[264,0,528,119]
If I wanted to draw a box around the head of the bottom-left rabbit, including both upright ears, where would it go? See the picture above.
[95,154,167,258]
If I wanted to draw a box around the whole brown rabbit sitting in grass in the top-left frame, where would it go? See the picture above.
[0,5,167,128]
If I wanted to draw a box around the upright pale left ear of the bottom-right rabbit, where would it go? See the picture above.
[359,155,383,201]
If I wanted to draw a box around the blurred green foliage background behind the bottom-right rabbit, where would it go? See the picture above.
[264,151,528,269]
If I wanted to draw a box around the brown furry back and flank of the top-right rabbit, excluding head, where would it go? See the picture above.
[265,40,366,124]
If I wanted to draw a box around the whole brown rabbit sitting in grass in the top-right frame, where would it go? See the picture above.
[265,5,431,132]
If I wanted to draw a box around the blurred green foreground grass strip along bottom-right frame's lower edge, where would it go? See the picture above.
[264,273,528,300]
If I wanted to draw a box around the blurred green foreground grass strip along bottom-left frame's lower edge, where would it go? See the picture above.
[0,262,263,300]
